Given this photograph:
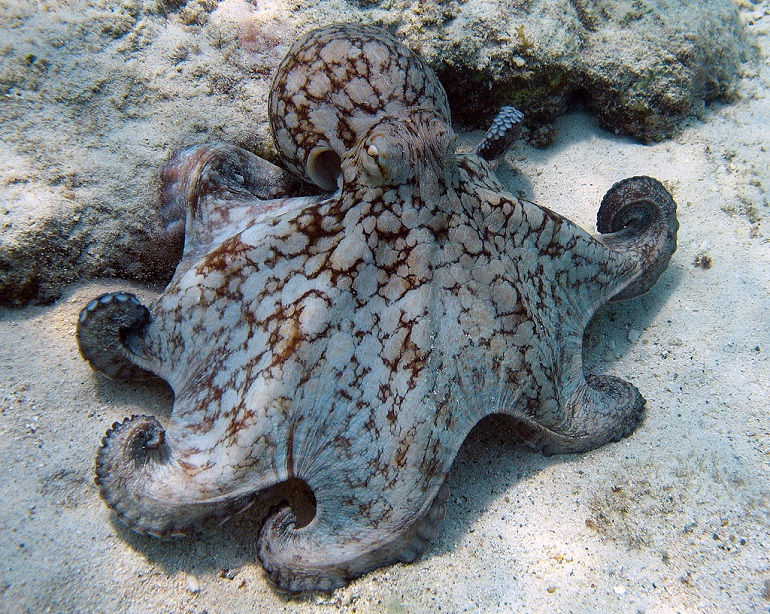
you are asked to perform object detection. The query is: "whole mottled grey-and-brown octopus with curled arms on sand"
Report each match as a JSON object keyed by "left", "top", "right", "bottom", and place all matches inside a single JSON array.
[{"left": 77, "top": 25, "right": 678, "bottom": 592}]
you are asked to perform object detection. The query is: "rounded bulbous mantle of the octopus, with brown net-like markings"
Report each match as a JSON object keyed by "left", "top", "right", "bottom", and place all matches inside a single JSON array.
[{"left": 269, "top": 24, "right": 450, "bottom": 182}]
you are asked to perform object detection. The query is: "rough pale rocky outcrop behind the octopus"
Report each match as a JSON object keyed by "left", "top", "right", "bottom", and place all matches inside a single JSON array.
[{"left": 0, "top": 0, "right": 748, "bottom": 305}]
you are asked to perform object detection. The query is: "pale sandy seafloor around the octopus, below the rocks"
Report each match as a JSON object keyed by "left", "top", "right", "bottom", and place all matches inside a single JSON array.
[{"left": 0, "top": 3, "right": 770, "bottom": 614}]
